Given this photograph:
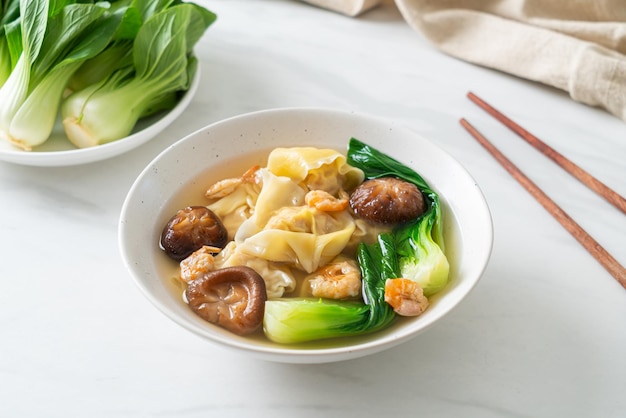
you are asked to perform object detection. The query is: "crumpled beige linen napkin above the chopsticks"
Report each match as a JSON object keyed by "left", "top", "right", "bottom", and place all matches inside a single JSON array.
[{"left": 300, "top": 0, "right": 626, "bottom": 121}]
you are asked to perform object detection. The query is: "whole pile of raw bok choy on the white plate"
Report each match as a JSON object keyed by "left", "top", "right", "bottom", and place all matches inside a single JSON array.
[{"left": 0, "top": 0, "right": 215, "bottom": 150}]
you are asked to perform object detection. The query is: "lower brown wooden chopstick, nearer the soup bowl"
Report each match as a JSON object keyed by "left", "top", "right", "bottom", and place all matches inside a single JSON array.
[{"left": 460, "top": 119, "right": 626, "bottom": 289}]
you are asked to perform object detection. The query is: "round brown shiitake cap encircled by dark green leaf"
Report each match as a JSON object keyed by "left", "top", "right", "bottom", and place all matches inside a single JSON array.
[{"left": 350, "top": 177, "right": 426, "bottom": 224}]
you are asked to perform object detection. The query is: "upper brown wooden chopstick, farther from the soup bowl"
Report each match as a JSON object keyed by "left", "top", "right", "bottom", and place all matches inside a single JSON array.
[{"left": 467, "top": 92, "right": 626, "bottom": 213}]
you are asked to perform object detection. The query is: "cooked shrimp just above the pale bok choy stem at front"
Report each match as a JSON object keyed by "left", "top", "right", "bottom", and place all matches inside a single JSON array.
[{"left": 309, "top": 260, "right": 361, "bottom": 299}]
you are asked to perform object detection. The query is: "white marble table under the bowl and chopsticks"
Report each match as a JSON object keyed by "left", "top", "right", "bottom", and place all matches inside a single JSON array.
[{"left": 0, "top": 0, "right": 626, "bottom": 418}]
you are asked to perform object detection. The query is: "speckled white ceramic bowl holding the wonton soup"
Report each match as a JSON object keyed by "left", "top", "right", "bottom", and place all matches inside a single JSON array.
[{"left": 119, "top": 109, "right": 493, "bottom": 363}]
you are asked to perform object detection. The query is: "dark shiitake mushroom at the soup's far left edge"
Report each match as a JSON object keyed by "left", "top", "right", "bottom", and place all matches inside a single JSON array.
[{"left": 160, "top": 206, "right": 228, "bottom": 261}]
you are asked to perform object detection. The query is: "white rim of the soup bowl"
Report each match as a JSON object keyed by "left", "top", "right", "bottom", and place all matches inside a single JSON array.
[{"left": 118, "top": 107, "right": 494, "bottom": 363}]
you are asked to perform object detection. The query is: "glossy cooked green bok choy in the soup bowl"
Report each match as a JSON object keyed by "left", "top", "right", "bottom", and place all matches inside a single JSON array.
[{"left": 263, "top": 138, "right": 449, "bottom": 343}]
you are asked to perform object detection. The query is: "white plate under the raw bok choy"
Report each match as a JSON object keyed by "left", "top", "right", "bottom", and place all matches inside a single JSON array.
[{"left": 0, "top": 66, "right": 200, "bottom": 167}]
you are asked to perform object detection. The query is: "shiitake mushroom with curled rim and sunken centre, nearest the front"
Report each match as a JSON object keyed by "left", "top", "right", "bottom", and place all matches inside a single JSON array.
[{"left": 185, "top": 266, "right": 267, "bottom": 335}]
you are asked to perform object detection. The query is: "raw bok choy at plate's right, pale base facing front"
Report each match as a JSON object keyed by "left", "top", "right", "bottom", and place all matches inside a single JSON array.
[{"left": 61, "top": 3, "right": 215, "bottom": 148}]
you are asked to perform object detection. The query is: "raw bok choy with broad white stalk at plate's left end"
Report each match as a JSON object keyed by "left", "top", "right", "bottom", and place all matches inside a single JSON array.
[{"left": 0, "top": 0, "right": 137, "bottom": 150}]
